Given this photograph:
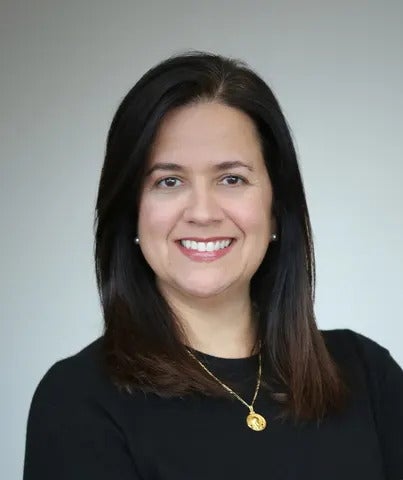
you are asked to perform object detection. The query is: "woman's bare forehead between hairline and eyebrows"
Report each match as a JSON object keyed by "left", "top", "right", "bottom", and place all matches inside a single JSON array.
[{"left": 150, "top": 102, "right": 261, "bottom": 162}]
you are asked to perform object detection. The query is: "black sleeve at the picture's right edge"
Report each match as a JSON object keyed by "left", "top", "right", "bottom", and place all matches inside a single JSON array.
[{"left": 355, "top": 333, "right": 403, "bottom": 480}]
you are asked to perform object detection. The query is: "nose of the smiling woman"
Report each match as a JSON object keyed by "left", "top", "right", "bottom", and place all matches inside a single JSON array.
[{"left": 183, "top": 182, "right": 224, "bottom": 225}]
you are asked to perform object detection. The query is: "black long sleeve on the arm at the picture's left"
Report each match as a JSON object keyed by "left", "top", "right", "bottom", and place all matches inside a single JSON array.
[{"left": 24, "top": 362, "right": 140, "bottom": 480}]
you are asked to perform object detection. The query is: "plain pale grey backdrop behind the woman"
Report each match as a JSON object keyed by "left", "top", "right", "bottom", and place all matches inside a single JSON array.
[{"left": 0, "top": 0, "right": 403, "bottom": 480}]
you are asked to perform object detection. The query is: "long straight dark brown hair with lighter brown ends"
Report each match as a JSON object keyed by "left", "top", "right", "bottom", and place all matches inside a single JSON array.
[{"left": 94, "top": 51, "right": 346, "bottom": 420}]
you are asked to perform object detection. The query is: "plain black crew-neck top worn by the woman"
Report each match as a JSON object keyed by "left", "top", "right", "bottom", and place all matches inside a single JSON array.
[{"left": 24, "top": 330, "right": 403, "bottom": 480}]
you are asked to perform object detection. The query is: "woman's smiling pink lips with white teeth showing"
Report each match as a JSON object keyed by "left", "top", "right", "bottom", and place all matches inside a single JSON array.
[{"left": 176, "top": 237, "right": 235, "bottom": 262}]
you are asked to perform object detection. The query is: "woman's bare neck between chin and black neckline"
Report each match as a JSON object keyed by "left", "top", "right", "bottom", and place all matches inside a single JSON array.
[{"left": 159, "top": 284, "right": 258, "bottom": 358}]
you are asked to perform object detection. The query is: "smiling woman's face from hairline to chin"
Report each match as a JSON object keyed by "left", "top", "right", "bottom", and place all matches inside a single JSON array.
[{"left": 138, "top": 103, "right": 274, "bottom": 298}]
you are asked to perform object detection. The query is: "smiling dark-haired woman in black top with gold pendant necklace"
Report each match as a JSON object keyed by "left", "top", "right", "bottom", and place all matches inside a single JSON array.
[{"left": 24, "top": 52, "right": 403, "bottom": 480}]
